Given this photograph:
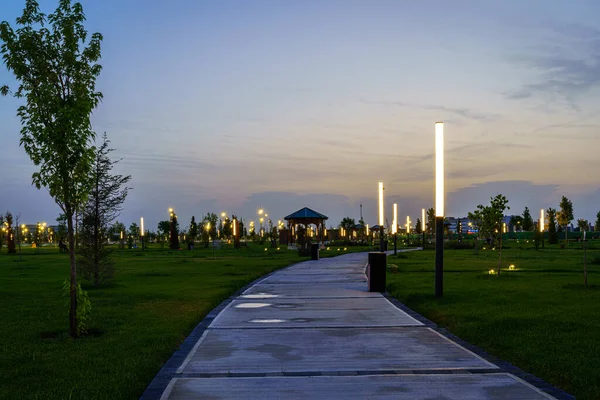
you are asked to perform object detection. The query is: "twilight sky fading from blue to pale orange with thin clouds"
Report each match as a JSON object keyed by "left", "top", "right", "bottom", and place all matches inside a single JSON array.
[{"left": 0, "top": 0, "right": 600, "bottom": 229}]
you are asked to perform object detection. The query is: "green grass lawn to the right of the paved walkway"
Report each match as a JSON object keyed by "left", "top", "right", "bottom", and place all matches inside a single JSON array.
[{"left": 387, "top": 241, "right": 600, "bottom": 399}]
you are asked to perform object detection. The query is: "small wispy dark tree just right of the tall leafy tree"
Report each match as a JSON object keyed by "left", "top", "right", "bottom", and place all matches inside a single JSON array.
[{"left": 78, "top": 133, "right": 131, "bottom": 286}]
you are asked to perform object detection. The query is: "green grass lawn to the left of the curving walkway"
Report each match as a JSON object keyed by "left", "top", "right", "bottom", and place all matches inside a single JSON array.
[{"left": 0, "top": 244, "right": 366, "bottom": 399}]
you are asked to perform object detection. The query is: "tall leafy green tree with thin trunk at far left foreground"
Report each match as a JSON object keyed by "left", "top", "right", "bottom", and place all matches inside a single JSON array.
[{"left": 0, "top": 0, "right": 102, "bottom": 337}]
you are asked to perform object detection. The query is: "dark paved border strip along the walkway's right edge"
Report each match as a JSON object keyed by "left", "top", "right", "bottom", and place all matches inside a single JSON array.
[{"left": 382, "top": 291, "right": 576, "bottom": 400}]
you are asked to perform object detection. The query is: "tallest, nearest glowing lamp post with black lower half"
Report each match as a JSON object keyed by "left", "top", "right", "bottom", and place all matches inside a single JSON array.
[{"left": 435, "top": 122, "right": 444, "bottom": 297}]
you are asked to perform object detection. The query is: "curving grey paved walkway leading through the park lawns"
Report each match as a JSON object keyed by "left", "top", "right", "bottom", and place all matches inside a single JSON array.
[{"left": 154, "top": 253, "right": 553, "bottom": 400}]
